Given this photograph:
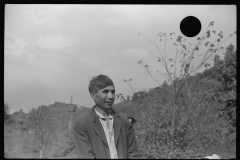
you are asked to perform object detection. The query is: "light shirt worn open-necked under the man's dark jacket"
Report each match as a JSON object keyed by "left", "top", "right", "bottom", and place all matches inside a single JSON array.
[{"left": 94, "top": 108, "right": 118, "bottom": 159}]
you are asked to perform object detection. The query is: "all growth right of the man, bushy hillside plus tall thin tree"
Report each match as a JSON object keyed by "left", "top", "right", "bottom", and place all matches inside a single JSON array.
[{"left": 117, "top": 21, "right": 236, "bottom": 158}]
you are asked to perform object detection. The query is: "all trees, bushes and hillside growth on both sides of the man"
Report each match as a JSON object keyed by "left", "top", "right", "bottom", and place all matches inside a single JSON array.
[{"left": 4, "top": 21, "right": 237, "bottom": 159}]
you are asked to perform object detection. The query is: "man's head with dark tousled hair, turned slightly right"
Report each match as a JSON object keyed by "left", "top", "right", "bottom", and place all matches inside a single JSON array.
[{"left": 88, "top": 75, "right": 115, "bottom": 109}]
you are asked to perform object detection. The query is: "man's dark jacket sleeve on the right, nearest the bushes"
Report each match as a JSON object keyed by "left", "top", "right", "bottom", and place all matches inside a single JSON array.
[{"left": 127, "top": 118, "right": 140, "bottom": 159}]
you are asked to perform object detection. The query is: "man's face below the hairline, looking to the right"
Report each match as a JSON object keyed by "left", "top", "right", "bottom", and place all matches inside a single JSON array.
[{"left": 91, "top": 85, "right": 115, "bottom": 109}]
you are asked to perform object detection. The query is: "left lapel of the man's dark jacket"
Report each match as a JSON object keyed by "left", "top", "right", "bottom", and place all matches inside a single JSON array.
[{"left": 92, "top": 107, "right": 108, "bottom": 147}]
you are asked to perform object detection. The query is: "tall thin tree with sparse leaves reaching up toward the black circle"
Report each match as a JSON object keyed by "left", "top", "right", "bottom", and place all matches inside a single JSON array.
[{"left": 138, "top": 21, "right": 236, "bottom": 158}]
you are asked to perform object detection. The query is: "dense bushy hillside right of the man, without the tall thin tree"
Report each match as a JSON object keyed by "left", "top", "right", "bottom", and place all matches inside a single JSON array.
[{"left": 114, "top": 45, "right": 236, "bottom": 158}]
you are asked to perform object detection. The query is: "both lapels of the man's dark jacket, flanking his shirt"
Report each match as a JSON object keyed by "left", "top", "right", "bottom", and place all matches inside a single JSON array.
[{"left": 92, "top": 106, "right": 121, "bottom": 147}]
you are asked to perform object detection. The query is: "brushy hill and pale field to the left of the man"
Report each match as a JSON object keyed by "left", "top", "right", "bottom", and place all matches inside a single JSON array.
[{"left": 4, "top": 102, "right": 89, "bottom": 158}]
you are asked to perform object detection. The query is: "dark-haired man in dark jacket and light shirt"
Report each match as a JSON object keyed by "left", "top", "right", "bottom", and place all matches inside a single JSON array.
[{"left": 74, "top": 75, "right": 138, "bottom": 159}]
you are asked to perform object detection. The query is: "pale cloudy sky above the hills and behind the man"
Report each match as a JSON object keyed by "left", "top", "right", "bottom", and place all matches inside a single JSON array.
[{"left": 4, "top": 4, "right": 236, "bottom": 112}]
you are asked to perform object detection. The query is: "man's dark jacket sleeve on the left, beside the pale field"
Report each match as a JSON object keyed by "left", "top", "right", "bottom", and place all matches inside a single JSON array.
[{"left": 73, "top": 123, "right": 96, "bottom": 158}]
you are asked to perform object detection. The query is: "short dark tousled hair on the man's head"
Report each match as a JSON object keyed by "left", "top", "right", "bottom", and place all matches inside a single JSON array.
[{"left": 88, "top": 74, "right": 114, "bottom": 93}]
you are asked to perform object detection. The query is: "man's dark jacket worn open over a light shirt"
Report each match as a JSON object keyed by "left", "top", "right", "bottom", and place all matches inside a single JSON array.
[{"left": 73, "top": 107, "right": 139, "bottom": 159}]
